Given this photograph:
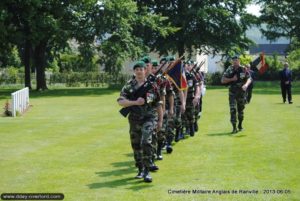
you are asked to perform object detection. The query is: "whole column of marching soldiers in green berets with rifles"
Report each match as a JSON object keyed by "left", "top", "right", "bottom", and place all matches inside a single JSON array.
[{"left": 117, "top": 56, "right": 205, "bottom": 182}]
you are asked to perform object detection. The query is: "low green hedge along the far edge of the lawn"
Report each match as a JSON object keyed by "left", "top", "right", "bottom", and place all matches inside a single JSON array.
[{"left": 0, "top": 68, "right": 300, "bottom": 87}]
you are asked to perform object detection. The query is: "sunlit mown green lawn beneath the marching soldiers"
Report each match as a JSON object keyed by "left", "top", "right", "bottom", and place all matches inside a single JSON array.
[{"left": 0, "top": 83, "right": 300, "bottom": 201}]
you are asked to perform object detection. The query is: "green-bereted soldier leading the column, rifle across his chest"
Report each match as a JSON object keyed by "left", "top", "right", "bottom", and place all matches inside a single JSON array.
[{"left": 117, "top": 61, "right": 162, "bottom": 182}]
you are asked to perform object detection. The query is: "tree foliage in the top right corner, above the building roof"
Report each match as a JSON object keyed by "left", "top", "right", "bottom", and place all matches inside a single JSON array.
[{"left": 258, "top": 0, "right": 300, "bottom": 44}]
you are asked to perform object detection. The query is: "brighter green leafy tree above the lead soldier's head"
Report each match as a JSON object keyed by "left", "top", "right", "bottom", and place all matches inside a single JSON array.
[{"left": 94, "top": 0, "right": 176, "bottom": 74}]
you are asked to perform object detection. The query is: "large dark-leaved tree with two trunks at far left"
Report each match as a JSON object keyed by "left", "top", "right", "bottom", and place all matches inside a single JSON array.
[{"left": 0, "top": 0, "right": 97, "bottom": 90}]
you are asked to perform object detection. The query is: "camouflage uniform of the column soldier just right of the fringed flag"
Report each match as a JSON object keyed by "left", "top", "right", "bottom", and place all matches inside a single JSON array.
[{"left": 182, "top": 72, "right": 199, "bottom": 136}]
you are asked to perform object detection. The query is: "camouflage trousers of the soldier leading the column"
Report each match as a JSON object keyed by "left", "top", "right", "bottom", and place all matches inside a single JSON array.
[{"left": 129, "top": 118, "right": 156, "bottom": 168}]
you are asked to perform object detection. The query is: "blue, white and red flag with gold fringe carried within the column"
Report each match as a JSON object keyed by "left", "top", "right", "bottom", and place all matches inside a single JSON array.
[{"left": 165, "top": 59, "right": 187, "bottom": 90}]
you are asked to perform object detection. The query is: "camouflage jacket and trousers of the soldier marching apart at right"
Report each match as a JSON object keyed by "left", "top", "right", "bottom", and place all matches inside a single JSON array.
[{"left": 223, "top": 66, "right": 251, "bottom": 128}]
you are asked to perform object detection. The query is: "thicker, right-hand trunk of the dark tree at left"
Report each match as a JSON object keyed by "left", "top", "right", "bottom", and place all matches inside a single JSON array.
[{"left": 34, "top": 41, "right": 48, "bottom": 91}]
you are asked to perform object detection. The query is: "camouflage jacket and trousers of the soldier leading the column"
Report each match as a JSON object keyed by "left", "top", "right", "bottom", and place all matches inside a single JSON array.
[{"left": 120, "top": 79, "right": 160, "bottom": 169}]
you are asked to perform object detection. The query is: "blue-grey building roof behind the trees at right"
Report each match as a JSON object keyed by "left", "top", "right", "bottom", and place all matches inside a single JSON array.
[{"left": 249, "top": 44, "right": 289, "bottom": 55}]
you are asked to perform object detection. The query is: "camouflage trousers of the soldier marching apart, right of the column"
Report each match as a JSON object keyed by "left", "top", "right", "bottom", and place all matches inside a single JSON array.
[{"left": 229, "top": 90, "right": 246, "bottom": 124}]
